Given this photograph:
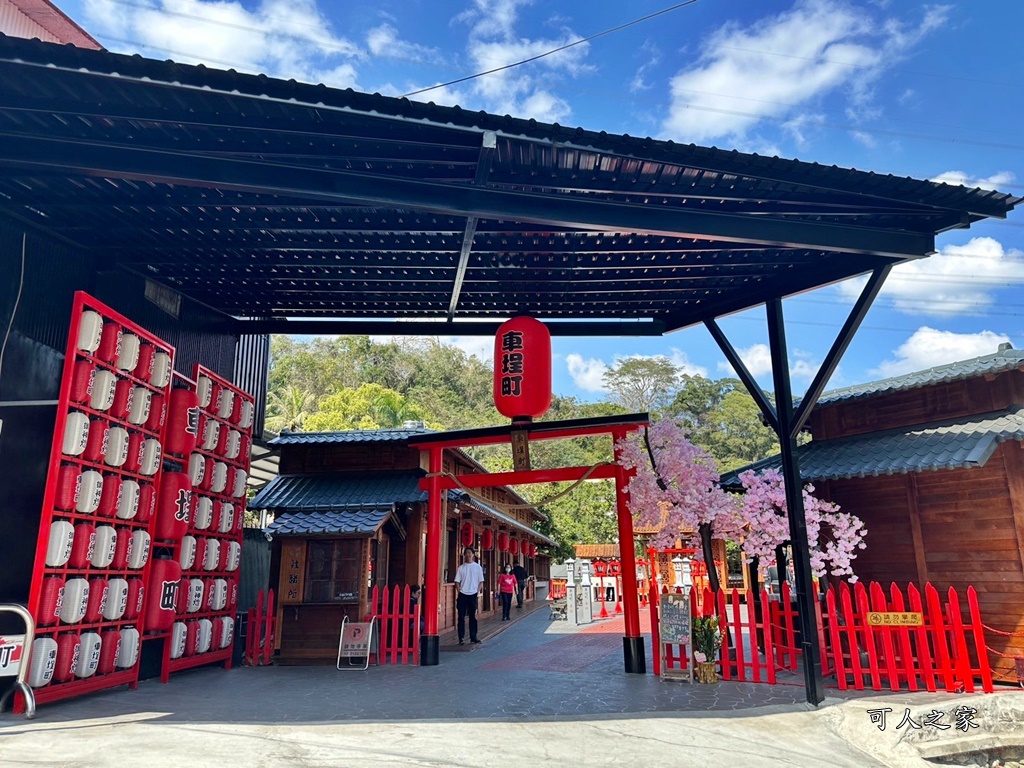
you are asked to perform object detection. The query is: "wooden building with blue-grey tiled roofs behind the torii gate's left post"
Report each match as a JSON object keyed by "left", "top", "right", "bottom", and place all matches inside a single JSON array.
[{"left": 250, "top": 425, "right": 554, "bottom": 664}]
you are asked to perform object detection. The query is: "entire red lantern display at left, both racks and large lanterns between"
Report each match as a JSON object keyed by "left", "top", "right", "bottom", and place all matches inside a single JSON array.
[{"left": 20, "top": 292, "right": 255, "bottom": 703}]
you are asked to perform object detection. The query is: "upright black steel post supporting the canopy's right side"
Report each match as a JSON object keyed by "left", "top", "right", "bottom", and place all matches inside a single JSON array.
[{"left": 766, "top": 299, "right": 825, "bottom": 706}]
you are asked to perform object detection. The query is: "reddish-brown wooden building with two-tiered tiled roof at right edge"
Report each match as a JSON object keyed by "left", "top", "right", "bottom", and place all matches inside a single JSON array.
[{"left": 722, "top": 344, "right": 1024, "bottom": 682}]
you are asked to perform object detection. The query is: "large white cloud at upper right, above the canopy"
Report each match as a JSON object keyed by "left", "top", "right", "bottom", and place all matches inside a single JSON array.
[{"left": 663, "top": 0, "right": 948, "bottom": 143}]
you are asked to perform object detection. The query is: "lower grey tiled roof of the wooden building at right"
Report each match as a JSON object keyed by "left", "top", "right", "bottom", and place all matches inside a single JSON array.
[{"left": 721, "top": 406, "right": 1024, "bottom": 488}]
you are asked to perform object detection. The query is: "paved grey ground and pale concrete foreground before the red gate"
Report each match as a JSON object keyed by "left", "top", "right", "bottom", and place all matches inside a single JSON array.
[{"left": 0, "top": 606, "right": 1024, "bottom": 768}]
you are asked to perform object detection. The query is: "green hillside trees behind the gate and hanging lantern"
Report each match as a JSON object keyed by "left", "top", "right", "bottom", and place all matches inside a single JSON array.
[{"left": 267, "top": 336, "right": 777, "bottom": 556}]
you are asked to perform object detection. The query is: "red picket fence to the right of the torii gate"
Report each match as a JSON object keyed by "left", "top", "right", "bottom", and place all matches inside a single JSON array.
[{"left": 651, "top": 583, "right": 992, "bottom": 692}]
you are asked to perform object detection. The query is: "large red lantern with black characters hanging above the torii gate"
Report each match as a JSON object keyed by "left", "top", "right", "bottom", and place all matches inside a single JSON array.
[{"left": 495, "top": 315, "right": 551, "bottom": 420}]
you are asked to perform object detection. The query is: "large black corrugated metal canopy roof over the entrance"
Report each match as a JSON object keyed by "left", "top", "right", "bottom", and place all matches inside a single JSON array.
[{"left": 0, "top": 36, "right": 1020, "bottom": 335}]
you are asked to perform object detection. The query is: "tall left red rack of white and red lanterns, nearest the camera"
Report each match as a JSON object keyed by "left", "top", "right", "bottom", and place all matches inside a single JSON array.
[{"left": 29, "top": 292, "right": 174, "bottom": 703}]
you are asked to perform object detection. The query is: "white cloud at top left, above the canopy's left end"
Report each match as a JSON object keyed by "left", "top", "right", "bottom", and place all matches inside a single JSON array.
[{"left": 83, "top": 0, "right": 366, "bottom": 88}]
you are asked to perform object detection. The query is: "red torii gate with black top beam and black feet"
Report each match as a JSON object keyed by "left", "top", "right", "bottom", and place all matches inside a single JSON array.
[{"left": 409, "top": 414, "right": 650, "bottom": 674}]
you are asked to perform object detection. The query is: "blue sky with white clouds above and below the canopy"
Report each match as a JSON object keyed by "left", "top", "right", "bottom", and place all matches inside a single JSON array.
[{"left": 57, "top": 0, "right": 1024, "bottom": 399}]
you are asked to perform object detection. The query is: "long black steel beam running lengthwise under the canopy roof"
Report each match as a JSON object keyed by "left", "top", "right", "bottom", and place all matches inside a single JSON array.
[{"left": 0, "top": 133, "right": 935, "bottom": 260}]
